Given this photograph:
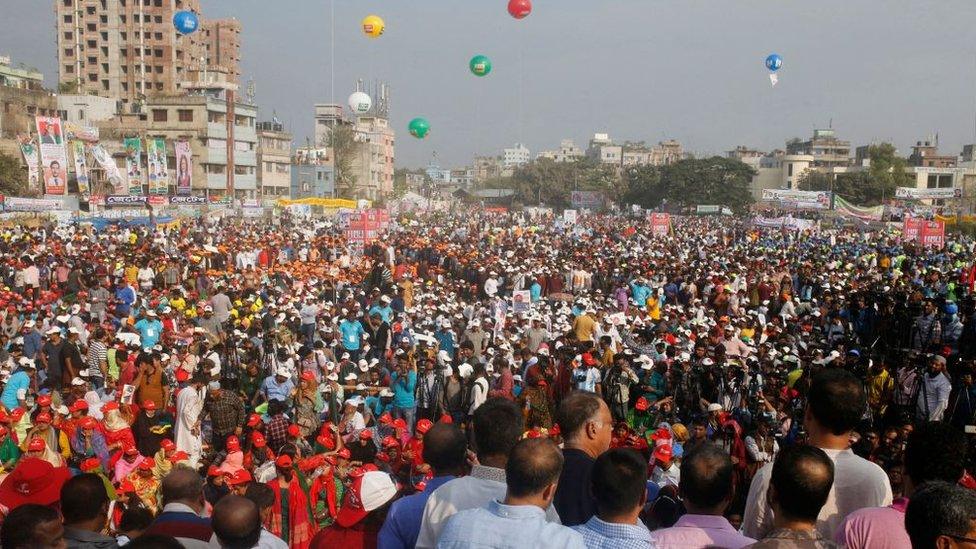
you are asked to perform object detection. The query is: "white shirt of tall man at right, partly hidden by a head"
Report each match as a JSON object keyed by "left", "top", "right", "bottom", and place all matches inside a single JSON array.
[{"left": 742, "top": 448, "right": 892, "bottom": 539}]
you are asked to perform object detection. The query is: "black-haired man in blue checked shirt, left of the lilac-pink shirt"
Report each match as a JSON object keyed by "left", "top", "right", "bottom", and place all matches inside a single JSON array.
[{"left": 573, "top": 448, "right": 654, "bottom": 549}]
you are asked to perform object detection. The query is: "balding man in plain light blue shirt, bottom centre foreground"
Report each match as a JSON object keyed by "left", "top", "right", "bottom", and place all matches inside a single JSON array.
[{"left": 437, "top": 438, "right": 586, "bottom": 549}]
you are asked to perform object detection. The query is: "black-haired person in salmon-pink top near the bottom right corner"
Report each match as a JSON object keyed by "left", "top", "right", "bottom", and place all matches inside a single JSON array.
[{"left": 834, "top": 423, "right": 966, "bottom": 549}]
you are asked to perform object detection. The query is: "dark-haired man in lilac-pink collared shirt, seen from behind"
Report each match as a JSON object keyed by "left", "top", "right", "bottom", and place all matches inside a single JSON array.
[{"left": 651, "top": 443, "right": 756, "bottom": 549}]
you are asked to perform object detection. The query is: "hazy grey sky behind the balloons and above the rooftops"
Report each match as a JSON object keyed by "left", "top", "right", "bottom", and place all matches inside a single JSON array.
[{"left": 0, "top": 0, "right": 976, "bottom": 167}]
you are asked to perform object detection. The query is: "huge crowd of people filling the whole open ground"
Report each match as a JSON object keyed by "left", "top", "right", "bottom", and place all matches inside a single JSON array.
[{"left": 0, "top": 207, "right": 976, "bottom": 549}]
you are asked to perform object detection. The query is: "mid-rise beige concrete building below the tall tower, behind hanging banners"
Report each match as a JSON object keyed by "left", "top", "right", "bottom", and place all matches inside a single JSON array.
[{"left": 93, "top": 72, "right": 258, "bottom": 199}]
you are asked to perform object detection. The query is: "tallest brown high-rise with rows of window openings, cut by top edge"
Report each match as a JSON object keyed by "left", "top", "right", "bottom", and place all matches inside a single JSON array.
[{"left": 55, "top": 0, "right": 206, "bottom": 104}]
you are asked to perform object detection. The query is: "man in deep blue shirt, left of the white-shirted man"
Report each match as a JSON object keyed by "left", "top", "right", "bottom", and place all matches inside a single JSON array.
[{"left": 378, "top": 423, "right": 467, "bottom": 549}]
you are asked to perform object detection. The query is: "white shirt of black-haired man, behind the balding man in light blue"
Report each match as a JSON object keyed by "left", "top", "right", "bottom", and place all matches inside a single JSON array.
[{"left": 416, "top": 465, "right": 560, "bottom": 549}]
